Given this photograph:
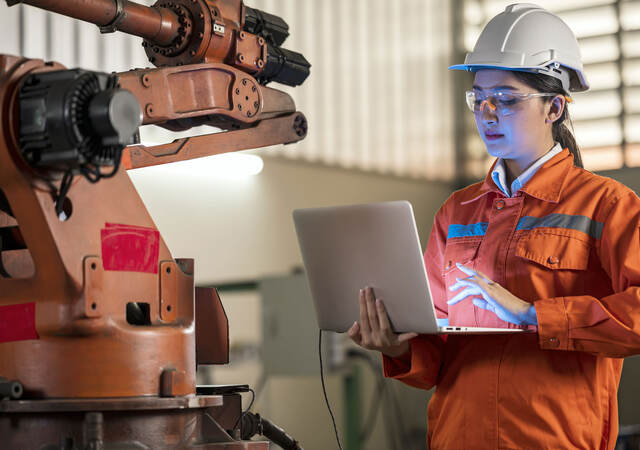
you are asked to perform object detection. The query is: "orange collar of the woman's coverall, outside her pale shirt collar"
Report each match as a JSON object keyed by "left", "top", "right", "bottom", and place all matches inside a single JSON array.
[{"left": 461, "top": 148, "right": 573, "bottom": 205}]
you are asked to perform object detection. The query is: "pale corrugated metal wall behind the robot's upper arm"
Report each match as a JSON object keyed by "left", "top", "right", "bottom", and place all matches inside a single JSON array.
[{"left": 0, "top": 0, "right": 454, "bottom": 180}]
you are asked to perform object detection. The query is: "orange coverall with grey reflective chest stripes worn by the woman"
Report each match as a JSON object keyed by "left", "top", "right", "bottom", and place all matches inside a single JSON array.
[{"left": 383, "top": 149, "right": 640, "bottom": 450}]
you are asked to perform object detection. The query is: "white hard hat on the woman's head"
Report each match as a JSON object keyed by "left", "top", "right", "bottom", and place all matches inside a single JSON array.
[{"left": 449, "top": 3, "right": 589, "bottom": 92}]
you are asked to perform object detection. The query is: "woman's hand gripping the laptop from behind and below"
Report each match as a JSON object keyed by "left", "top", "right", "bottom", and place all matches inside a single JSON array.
[{"left": 347, "top": 287, "right": 418, "bottom": 358}]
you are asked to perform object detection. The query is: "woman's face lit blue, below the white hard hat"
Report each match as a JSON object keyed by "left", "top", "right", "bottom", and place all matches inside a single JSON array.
[{"left": 473, "top": 69, "right": 553, "bottom": 167}]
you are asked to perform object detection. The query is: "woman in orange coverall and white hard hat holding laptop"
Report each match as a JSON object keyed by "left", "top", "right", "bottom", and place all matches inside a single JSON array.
[{"left": 349, "top": 4, "right": 640, "bottom": 449}]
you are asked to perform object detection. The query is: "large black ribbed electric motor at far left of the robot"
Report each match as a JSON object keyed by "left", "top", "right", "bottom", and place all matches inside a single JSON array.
[{"left": 18, "top": 69, "right": 142, "bottom": 216}]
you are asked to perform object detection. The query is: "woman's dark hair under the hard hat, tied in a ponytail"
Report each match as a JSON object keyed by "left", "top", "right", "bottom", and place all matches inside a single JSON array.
[{"left": 513, "top": 71, "right": 584, "bottom": 167}]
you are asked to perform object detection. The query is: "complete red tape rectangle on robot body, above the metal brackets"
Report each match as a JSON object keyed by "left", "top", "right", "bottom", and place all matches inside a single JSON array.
[{"left": 100, "top": 223, "right": 160, "bottom": 273}]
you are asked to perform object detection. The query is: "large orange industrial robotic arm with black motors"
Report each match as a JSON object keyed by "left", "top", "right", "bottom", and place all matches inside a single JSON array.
[{"left": 0, "top": 0, "right": 310, "bottom": 449}]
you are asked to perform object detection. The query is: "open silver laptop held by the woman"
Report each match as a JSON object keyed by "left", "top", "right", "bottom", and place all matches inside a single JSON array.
[{"left": 293, "top": 201, "right": 528, "bottom": 334}]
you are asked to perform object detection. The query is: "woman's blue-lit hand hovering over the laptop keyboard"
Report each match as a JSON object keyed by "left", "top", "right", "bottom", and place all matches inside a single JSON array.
[{"left": 447, "top": 263, "right": 538, "bottom": 325}]
